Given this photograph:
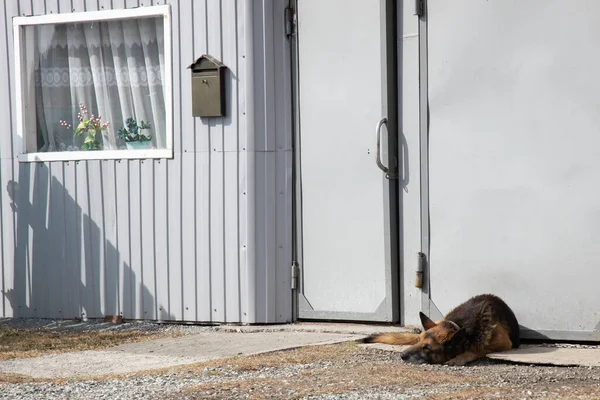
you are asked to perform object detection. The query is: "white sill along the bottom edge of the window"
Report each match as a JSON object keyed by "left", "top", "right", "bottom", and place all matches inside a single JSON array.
[{"left": 18, "top": 149, "right": 173, "bottom": 162}]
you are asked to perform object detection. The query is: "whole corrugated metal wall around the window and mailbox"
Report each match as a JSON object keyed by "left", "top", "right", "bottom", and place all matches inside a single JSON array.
[{"left": 0, "top": 0, "right": 292, "bottom": 323}]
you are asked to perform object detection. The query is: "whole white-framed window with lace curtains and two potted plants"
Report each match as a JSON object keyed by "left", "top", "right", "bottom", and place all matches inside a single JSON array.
[{"left": 14, "top": 5, "right": 173, "bottom": 161}]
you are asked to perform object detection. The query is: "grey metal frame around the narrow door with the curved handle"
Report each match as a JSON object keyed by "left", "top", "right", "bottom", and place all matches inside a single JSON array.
[{"left": 288, "top": 0, "right": 402, "bottom": 323}]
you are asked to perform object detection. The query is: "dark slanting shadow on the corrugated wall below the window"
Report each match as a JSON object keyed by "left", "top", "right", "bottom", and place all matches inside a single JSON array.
[{"left": 4, "top": 163, "right": 173, "bottom": 320}]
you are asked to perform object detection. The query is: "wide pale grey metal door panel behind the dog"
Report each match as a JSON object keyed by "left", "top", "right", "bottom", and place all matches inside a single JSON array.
[{"left": 427, "top": 0, "right": 600, "bottom": 340}]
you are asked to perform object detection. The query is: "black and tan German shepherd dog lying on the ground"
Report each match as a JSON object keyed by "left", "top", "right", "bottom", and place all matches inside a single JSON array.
[{"left": 364, "top": 294, "right": 520, "bottom": 365}]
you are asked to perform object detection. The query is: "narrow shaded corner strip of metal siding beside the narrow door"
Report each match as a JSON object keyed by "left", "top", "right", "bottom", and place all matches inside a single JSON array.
[{"left": 254, "top": 0, "right": 293, "bottom": 321}]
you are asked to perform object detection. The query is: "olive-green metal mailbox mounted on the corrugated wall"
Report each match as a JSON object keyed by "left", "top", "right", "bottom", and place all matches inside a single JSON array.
[{"left": 188, "top": 54, "right": 226, "bottom": 117}]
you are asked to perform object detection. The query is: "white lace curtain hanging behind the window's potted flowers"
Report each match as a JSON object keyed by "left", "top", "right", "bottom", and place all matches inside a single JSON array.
[{"left": 31, "top": 18, "right": 166, "bottom": 152}]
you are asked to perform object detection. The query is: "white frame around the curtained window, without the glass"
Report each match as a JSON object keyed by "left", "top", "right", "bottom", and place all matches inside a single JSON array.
[{"left": 13, "top": 4, "right": 173, "bottom": 162}]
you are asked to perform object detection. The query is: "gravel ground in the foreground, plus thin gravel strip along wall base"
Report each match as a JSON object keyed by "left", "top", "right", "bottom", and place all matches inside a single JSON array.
[{"left": 0, "top": 320, "right": 600, "bottom": 400}]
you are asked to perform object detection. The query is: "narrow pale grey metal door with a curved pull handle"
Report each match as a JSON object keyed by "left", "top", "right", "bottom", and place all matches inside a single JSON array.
[{"left": 297, "top": 0, "right": 397, "bottom": 321}]
